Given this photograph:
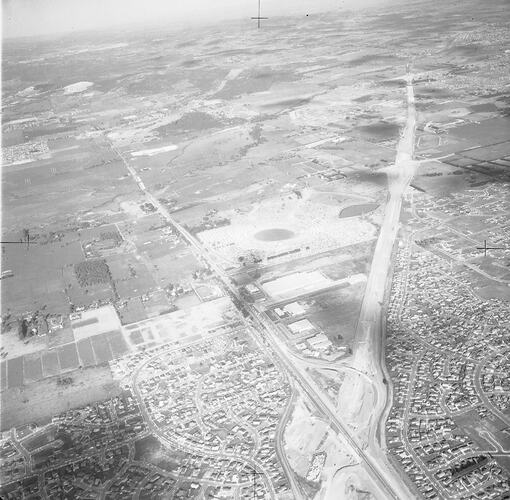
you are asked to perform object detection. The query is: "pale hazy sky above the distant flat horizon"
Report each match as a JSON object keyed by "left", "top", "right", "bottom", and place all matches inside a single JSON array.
[{"left": 2, "top": 0, "right": 388, "bottom": 37}]
